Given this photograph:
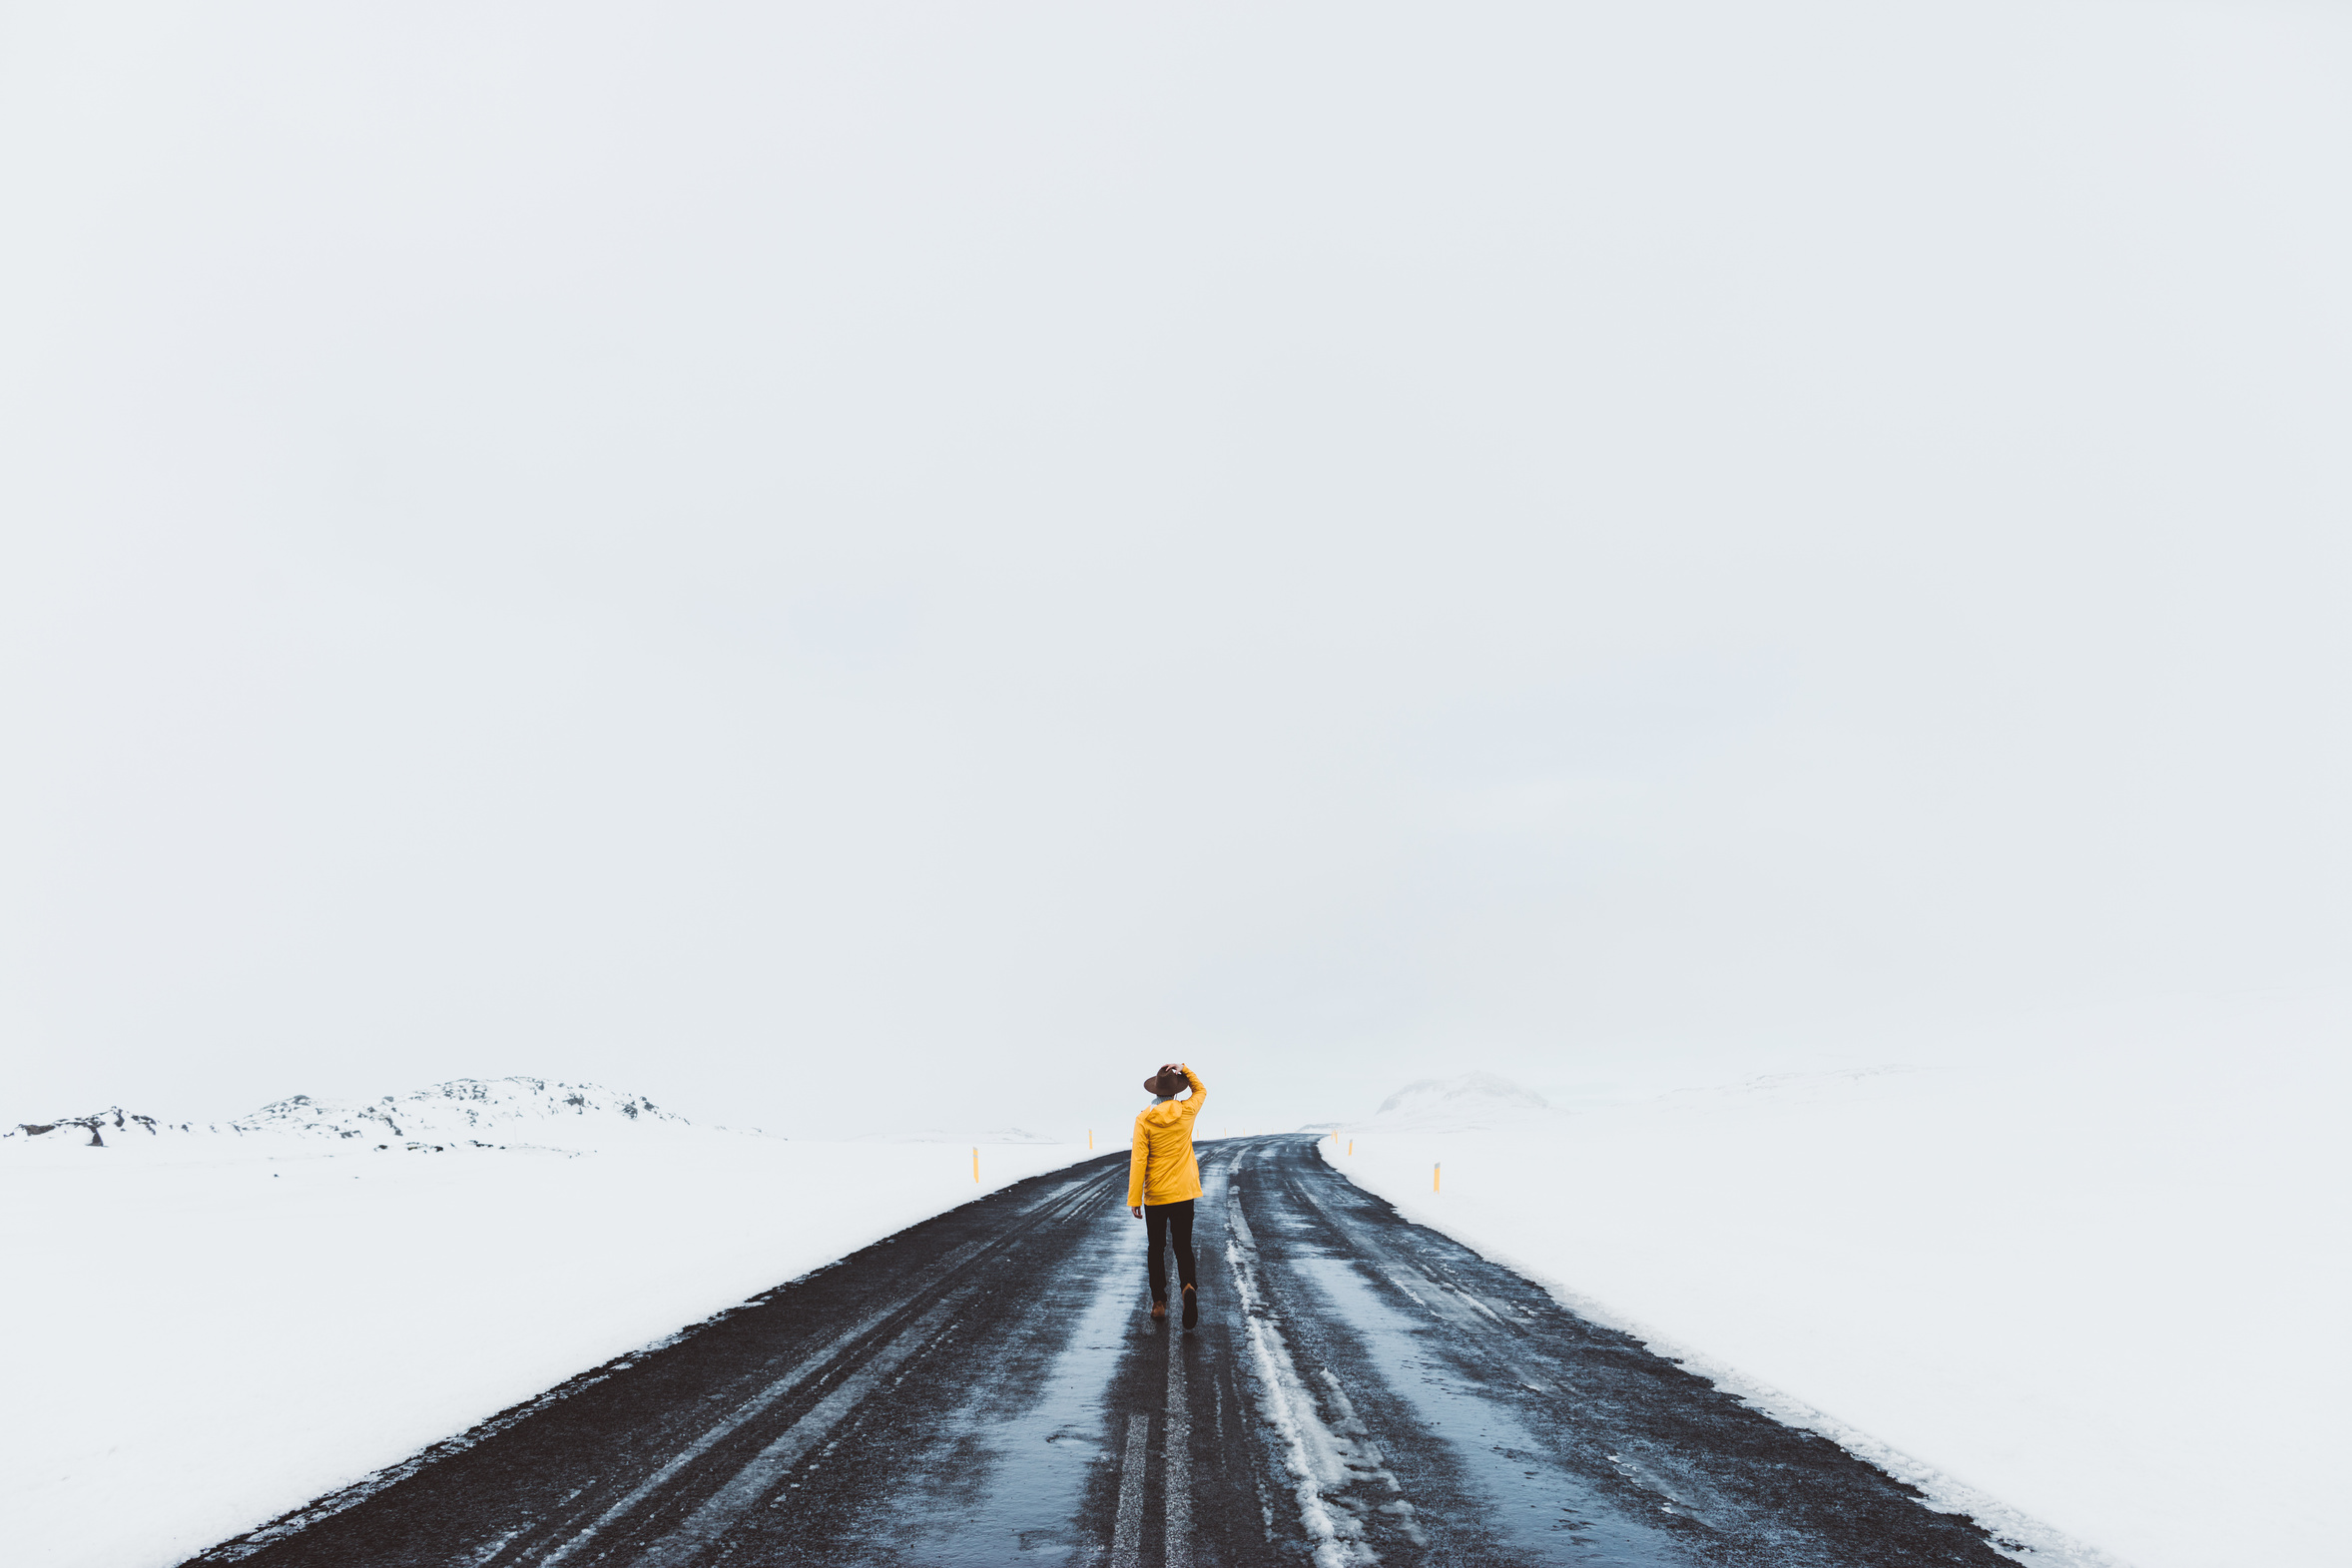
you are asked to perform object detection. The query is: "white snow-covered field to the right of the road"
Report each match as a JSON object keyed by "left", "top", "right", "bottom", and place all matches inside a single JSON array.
[{"left": 1322, "top": 1004, "right": 2352, "bottom": 1568}]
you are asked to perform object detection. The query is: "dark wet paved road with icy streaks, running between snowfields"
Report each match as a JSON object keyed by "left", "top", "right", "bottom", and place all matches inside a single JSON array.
[{"left": 196, "top": 1138, "right": 2009, "bottom": 1568}]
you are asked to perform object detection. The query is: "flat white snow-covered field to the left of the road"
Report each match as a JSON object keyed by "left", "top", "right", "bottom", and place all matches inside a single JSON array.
[{"left": 0, "top": 1086, "right": 1086, "bottom": 1568}]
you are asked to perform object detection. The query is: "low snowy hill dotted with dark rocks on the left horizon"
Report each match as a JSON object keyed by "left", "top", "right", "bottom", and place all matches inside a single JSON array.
[{"left": 0, "top": 1077, "right": 729, "bottom": 1150}]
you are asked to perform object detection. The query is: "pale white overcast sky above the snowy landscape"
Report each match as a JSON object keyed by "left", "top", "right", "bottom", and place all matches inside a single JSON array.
[{"left": 0, "top": 0, "right": 2352, "bottom": 1133}]
